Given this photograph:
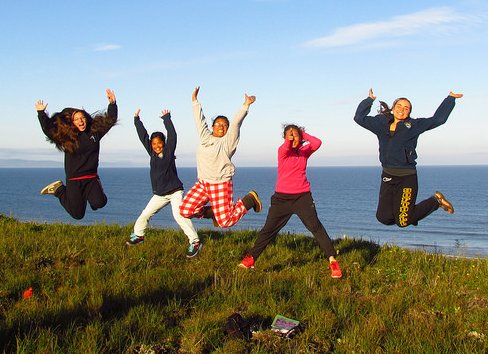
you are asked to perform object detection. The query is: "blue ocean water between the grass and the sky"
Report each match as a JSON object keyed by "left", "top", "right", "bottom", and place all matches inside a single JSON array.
[{"left": 0, "top": 166, "right": 488, "bottom": 257}]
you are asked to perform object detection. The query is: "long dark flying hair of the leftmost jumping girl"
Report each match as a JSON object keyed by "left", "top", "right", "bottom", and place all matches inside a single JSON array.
[{"left": 48, "top": 107, "right": 115, "bottom": 154}]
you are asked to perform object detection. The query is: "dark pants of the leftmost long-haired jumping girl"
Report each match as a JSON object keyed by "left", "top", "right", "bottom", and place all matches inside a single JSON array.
[{"left": 55, "top": 177, "right": 108, "bottom": 220}]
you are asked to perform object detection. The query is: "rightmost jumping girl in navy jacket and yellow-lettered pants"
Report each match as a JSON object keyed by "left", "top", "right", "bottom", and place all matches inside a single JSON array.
[{"left": 354, "top": 89, "right": 463, "bottom": 227}]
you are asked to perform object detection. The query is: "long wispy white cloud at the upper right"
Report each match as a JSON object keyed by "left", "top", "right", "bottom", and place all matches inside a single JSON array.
[{"left": 304, "top": 7, "right": 473, "bottom": 48}]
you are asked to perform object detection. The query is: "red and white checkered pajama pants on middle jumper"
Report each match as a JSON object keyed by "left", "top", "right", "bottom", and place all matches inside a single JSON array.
[{"left": 180, "top": 179, "right": 247, "bottom": 227}]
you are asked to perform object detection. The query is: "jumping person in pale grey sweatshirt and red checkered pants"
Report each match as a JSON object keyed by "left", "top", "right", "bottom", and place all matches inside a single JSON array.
[{"left": 180, "top": 87, "right": 262, "bottom": 227}]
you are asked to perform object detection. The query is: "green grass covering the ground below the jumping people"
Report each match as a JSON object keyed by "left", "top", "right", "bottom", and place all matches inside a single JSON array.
[{"left": 0, "top": 215, "right": 488, "bottom": 353}]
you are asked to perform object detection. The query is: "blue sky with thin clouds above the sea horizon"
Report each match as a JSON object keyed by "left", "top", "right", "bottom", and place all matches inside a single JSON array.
[{"left": 0, "top": 0, "right": 488, "bottom": 167}]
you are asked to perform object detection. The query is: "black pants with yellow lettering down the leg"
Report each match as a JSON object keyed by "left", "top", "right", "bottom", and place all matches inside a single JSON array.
[{"left": 376, "top": 172, "right": 439, "bottom": 227}]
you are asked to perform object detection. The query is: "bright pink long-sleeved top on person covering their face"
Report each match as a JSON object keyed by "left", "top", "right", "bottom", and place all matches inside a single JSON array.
[{"left": 276, "top": 132, "right": 322, "bottom": 194}]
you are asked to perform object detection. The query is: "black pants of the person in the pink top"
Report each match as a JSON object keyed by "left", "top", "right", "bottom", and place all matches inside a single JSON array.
[{"left": 249, "top": 192, "right": 336, "bottom": 260}]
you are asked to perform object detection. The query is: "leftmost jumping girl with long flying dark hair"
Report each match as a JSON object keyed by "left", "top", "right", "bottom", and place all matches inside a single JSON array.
[{"left": 35, "top": 89, "right": 117, "bottom": 219}]
